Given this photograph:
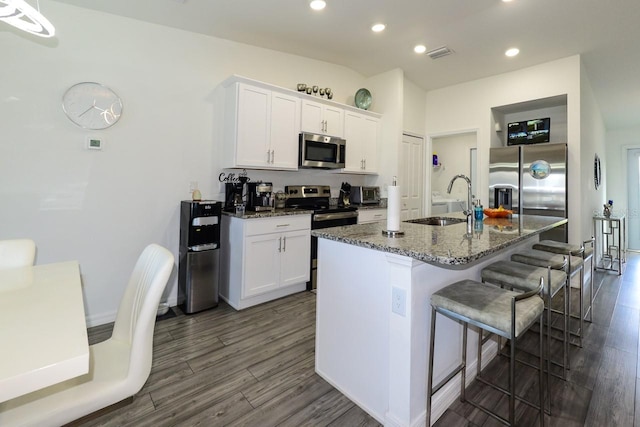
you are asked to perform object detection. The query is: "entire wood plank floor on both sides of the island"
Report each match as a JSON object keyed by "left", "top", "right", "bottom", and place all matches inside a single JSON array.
[{"left": 82, "top": 255, "right": 640, "bottom": 427}]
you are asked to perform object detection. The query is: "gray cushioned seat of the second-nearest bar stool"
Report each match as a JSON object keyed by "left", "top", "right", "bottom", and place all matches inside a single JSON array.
[{"left": 481, "top": 260, "right": 567, "bottom": 296}]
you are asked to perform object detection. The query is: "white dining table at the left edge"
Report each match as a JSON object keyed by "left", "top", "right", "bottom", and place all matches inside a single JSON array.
[{"left": 0, "top": 261, "right": 89, "bottom": 402}]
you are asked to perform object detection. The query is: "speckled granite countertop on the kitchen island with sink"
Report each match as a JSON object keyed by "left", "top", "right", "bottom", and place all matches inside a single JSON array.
[{"left": 311, "top": 213, "right": 567, "bottom": 268}]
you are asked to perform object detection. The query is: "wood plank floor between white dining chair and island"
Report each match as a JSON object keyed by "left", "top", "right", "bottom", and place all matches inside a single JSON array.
[{"left": 82, "top": 292, "right": 380, "bottom": 427}]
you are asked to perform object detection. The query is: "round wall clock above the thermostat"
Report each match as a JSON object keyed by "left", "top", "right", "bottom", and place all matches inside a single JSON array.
[{"left": 62, "top": 82, "right": 122, "bottom": 130}]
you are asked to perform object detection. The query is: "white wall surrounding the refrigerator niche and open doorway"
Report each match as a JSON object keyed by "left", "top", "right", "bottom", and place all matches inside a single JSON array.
[{"left": 426, "top": 56, "right": 592, "bottom": 241}]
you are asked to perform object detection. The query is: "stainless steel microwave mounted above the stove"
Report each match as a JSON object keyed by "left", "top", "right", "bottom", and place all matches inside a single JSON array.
[{"left": 298, "top": 132, "right": 347, "bottom": 169}]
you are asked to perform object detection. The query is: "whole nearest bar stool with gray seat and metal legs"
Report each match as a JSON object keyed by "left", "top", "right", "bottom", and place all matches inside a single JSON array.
[{"left": 427, "top": 277, "right": 544, "bottom": 427}]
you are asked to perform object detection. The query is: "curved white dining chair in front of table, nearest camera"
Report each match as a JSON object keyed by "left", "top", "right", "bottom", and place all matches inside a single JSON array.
[{"left": 0, "top": 244, "right": 174, "bottom": 427}]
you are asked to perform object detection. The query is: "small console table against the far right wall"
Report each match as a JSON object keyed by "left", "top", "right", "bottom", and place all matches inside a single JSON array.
[{"left": 593, "top": 214, "right": 627, "bottom": 275}]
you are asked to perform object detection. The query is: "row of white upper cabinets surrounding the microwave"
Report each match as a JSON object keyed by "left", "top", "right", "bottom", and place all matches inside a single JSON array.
[{"left": 220, "top": 76, "right": 380, "bottom": 174}]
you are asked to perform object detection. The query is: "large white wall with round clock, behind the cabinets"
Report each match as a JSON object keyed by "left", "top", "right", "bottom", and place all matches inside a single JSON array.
[{"left": 0, "top": 0, "right": 384, "bottom": 325}]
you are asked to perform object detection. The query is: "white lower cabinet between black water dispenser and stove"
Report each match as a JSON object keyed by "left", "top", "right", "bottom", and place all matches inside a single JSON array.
[{"left": 220, "top": 215, "right": 311, "bottom": 310}]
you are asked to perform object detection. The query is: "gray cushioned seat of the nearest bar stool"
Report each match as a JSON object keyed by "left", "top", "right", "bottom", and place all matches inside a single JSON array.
[{"left": 431, "top": 277, "right": 544, "bottom": 337}]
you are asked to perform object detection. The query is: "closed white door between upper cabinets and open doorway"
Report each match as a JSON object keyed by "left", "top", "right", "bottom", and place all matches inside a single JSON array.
[{"left": 399, "top": 134, "right": 425, "bottom": 221}]
